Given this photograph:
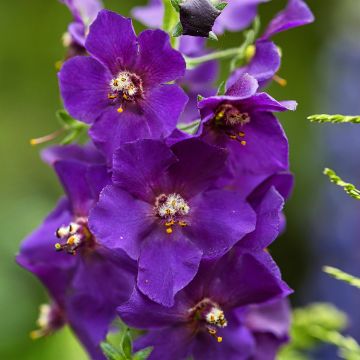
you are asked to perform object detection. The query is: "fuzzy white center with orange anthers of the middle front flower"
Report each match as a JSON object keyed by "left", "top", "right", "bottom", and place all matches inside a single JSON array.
[{"left": 154, "top": 193, "right": 190, "bottom": 234}]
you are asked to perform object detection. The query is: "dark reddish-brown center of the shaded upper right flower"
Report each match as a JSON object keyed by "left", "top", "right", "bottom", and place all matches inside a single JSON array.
[{"left": 213, "top": 104, "right": 251, "bottom": 146}]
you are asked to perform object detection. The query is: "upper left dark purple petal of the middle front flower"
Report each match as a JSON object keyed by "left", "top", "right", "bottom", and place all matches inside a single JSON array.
[{"left": 113, "top": 139, "right": 178, "bottom": 201}]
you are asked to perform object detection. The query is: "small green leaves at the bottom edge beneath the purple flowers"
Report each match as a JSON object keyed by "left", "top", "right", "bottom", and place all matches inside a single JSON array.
[{"left": 101, "top": 326, "right": 152, "bottom": 360}]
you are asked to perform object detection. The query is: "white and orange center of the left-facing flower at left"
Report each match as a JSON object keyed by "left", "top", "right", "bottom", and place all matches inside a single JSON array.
[{"left": 55, "top": 218, "right": 95, "bottom": 255}]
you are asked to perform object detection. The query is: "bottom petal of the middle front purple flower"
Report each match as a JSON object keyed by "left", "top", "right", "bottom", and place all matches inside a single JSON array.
[{"left": 138, "top": 229, "right": 202, "bottom": 307}]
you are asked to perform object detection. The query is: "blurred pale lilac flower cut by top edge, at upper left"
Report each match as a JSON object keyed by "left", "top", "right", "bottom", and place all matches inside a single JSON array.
[{"left": 60, "top": 0, "right": 103, "bottom": 50}]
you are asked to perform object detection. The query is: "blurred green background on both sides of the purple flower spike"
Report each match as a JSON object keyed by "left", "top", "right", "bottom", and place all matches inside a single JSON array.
[{"left": 0, "top": 0, "right": 359, "bottom": 360}]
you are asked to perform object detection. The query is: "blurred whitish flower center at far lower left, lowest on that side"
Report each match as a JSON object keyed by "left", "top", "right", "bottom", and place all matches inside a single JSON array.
[{"left": 30, "top": 303, "right": 65, "bottom": 339}]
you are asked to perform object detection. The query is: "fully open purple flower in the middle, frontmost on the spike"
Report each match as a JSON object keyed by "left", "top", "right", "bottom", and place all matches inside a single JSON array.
[{"left": 90, "top": 139, "right": 256, "bottom": 306}]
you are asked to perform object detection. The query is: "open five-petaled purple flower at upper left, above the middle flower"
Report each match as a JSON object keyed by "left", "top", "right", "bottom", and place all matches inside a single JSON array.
[{"left": 59, "top": 10, "right": 187, "bottom": 161}]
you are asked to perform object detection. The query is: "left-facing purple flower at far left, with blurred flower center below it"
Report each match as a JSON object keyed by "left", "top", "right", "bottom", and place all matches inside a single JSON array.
[{"left": 17, "top": 145, "right": 136, "bottom": 359}]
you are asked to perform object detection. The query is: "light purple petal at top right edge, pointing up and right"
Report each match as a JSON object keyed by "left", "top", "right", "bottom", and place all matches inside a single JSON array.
[{"left": 262, "top": 0, "right": 314, "bottom": 39}]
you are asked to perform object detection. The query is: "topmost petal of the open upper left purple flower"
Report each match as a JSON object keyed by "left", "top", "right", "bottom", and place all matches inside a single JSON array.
[{"left": 85, "top": 10, "right": 138, "bottom": 76}]
